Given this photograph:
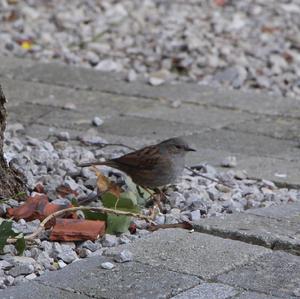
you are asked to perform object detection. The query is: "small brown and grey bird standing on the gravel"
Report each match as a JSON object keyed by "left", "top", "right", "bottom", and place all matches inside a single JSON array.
[{"left": 79, "top": 138, "right": 195, "bottom": 189}]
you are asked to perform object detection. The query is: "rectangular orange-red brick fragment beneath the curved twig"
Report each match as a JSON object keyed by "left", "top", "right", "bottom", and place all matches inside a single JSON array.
[{"left": 50, "top": 218, "right": 105, "bottom": 241}]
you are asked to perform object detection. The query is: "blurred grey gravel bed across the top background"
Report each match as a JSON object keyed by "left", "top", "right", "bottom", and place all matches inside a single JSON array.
[{"left": 0, "top": 0, "right": 300, "bottom": 98}]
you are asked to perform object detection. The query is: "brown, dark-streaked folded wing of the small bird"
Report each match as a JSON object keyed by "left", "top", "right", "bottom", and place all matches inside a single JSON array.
[{"left": 113, "top": 146, "right": 160, "bottom": 170}]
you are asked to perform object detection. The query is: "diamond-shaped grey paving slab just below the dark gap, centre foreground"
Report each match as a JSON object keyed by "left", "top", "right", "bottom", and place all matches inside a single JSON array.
[{"left": 106, "top": 229, "right": 270, "bottom": 279}]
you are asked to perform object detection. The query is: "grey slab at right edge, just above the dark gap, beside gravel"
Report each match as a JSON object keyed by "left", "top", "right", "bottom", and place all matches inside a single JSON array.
[{"left": 194, "top": 213, "right": 300, "bottom": 255}]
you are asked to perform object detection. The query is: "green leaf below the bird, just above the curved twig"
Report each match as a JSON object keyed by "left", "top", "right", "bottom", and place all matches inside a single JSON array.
[{"left": 102, "top": 191, "right": 139, "bottom": 213}]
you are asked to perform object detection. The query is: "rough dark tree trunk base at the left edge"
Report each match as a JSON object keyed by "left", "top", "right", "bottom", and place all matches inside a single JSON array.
[{"left": 0, "top": 84, "right": 26, "bottom": 198}]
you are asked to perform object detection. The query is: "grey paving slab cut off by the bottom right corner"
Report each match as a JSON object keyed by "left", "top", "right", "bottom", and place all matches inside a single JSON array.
[{"left": 217, "top": 251, "right": 300, "bottom": 298}]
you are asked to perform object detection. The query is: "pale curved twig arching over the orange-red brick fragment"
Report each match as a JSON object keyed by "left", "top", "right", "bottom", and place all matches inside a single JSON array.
[{"left": 7, "top": 206, "right": 152, "bottom": 243}]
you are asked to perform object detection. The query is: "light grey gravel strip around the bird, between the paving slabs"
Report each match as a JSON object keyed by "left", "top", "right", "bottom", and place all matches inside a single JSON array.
[{"left": 0, "top": 124, "right": 300, "bottom": 289}]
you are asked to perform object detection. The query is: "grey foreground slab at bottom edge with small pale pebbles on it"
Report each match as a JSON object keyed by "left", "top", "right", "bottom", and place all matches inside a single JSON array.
[{"left": 37, "top": 257, "right": 201, "bottom": 299}]
